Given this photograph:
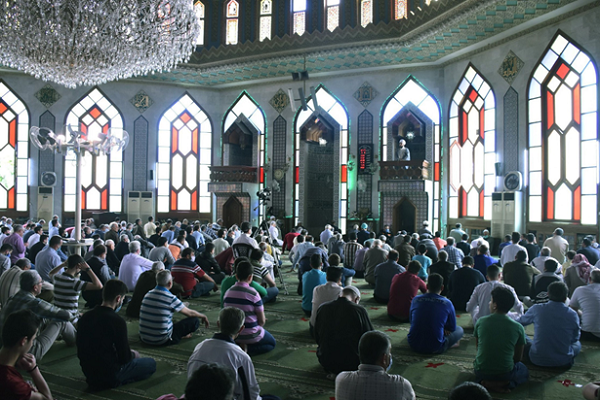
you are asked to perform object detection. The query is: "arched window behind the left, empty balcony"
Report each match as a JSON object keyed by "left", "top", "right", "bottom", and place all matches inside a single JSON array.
[{"left": 223, "top": 91, "right": 267, "bottom": 221}]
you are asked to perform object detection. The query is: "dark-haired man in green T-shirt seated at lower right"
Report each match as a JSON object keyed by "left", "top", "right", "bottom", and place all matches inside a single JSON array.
[{"left": 473, "top": 286, "right": 529, "bottom": 393}]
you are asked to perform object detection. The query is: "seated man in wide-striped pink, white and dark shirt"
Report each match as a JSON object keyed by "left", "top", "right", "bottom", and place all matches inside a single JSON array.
[{"left": 223, "top": 261, "right": 276, "bottom": 356}]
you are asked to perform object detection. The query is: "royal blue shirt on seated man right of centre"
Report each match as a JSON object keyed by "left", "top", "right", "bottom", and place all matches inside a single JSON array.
[{"left": 408, "top": 293, "right": 456, "bottom": 354}]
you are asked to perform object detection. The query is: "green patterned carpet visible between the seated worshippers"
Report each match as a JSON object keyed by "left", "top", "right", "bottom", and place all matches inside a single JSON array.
[{"left": 41, "top": 258, "right": 600, "bottom": 400}]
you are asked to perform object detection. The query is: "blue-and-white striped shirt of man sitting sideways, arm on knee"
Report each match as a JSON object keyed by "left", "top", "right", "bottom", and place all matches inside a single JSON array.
[{"left": 140, "top": 286, "right": 185, "bottom": 345}]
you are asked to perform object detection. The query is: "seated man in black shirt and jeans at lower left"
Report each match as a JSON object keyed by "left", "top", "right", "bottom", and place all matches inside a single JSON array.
[{"left": 77, "top": 279, "right": 156, "bottom": 390}]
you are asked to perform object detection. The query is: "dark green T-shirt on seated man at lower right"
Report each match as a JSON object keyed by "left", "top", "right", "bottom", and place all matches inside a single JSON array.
[{"left": 473, "top": 313, "right": 525, "bottom": 375}]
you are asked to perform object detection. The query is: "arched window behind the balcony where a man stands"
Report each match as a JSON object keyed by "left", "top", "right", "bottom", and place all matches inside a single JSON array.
[{"left": 380, "top": 76, "right": 441, "bottom": 230}]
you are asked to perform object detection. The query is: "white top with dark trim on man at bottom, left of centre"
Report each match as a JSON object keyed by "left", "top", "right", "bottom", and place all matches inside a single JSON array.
[{"left": 188, "top": 338, "right": 262, "bottom": 400}]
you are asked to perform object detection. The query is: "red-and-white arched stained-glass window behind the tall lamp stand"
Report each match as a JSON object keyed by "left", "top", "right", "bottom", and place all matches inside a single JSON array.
[{"left": 64, "top": 88, "right": 123, "bottom": 213}]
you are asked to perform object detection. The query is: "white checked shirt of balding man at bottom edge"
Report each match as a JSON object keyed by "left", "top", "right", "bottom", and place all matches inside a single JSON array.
[{"left": 335, "top": 364, "right": 416, "bottom": 400}]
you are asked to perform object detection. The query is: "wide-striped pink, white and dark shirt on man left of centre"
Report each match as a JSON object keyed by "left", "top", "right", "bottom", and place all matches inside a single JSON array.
[{"left": 223, "top": 282, "right": 265, "bottom": 344}]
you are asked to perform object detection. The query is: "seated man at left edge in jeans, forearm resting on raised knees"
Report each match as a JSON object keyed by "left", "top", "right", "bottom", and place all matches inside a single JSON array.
[{"left": 0, "top": 270, "right": 75, "bottom": 361}]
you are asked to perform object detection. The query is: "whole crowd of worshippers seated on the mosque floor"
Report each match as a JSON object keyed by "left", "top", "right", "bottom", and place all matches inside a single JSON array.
[{"left": 0, "top": 217, "right": 600, "bottom": 400}]
